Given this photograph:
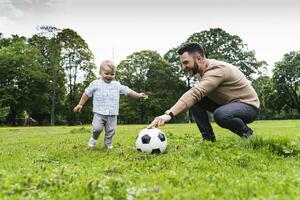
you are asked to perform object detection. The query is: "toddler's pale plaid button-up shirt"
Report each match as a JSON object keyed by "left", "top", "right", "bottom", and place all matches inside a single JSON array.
[{"left": 84, "top": 80, "right": 131, "bottom": 115}]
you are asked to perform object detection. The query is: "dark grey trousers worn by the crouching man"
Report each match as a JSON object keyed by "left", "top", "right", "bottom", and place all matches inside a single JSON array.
[{"left": 191, "top": 97, "right": 258, "bottom": 140}]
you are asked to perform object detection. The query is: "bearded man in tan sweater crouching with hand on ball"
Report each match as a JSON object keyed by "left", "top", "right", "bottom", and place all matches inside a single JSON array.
[{"left": 148, "top": 43, "right": 259, "bottom": 142}]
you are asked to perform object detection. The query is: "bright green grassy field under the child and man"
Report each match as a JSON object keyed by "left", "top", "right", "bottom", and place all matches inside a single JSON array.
[{"left": 0, "top": 120, "right": 300, "bottom": 200}]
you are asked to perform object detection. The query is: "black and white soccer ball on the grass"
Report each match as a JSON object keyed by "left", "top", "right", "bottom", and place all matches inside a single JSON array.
[{"left": 135, "top": 128, "right": 167, "bottom": 154}]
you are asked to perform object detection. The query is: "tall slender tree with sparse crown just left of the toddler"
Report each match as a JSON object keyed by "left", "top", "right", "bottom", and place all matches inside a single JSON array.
[{"left": 58, "top": 29, "right": 95, "bottom": 125}]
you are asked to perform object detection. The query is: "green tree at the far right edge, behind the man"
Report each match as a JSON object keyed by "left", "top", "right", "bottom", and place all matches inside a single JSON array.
[{"left": 272, "top": 51, "right": 300, "bottom": 117}]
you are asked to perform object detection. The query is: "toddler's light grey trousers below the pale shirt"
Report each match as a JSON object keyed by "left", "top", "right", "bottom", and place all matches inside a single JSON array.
[{"left": 92, "top": 113, "right": 117, "bottom": 146}]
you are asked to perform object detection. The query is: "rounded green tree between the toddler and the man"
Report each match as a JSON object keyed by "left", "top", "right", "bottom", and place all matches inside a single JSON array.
[{"left": 117, "top": 50, "right": 185, "bottom": 123}]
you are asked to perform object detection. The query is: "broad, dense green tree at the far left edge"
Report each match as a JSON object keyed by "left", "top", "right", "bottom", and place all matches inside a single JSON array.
[{"left": 0, "top": 36, "right": 49, "bottom": 125}]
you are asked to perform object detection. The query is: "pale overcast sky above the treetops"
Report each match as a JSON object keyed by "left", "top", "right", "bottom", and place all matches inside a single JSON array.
[{"left": 0, "top": 0, "right": 300, "bottom": 73}]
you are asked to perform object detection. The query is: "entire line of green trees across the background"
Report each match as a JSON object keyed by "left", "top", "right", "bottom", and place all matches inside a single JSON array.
[{"left": 0, "top": 26, "right": 300, "bottom": 125}]
